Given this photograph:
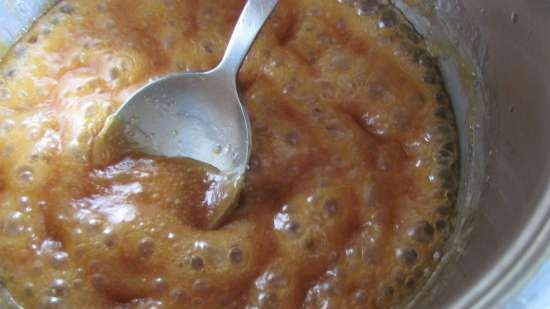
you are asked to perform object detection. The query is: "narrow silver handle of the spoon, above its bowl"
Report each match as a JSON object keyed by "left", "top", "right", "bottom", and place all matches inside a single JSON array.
[{"left": 216, "top": 0, "right": 279, "bottom": 80}]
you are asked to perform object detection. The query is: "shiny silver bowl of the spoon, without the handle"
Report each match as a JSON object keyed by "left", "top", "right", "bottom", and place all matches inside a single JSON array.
[{"left": 115, "top": 69, "right": 251, "bottom": 174}]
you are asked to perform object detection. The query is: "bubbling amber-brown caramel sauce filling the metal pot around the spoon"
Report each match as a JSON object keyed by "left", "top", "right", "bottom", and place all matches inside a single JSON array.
[{"left": 0, "top": 0, "right": 458, "bottom": 309}]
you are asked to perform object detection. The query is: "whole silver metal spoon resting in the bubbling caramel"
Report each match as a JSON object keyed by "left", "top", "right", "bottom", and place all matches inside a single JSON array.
[{"left": 100, "top": 0, "right": 279, "bottom": 228}]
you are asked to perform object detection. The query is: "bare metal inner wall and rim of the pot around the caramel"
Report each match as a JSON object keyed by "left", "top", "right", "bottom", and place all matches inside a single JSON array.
[{"left": 0, "top": 0, "right": 550, "bottom": 309}]
